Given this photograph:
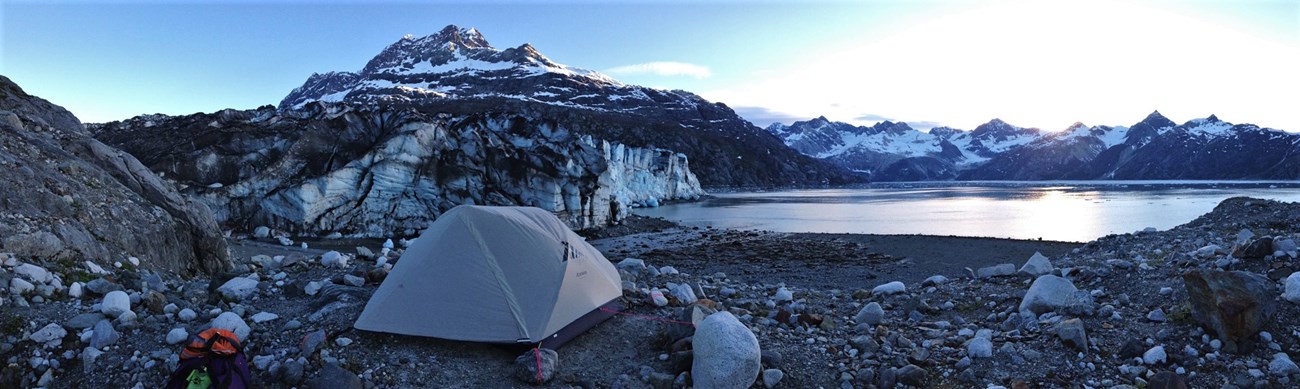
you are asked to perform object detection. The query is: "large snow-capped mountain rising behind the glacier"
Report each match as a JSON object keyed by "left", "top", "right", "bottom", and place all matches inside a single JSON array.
[{"left": 280, "top": 26, "right": 865, "bottom": 186}]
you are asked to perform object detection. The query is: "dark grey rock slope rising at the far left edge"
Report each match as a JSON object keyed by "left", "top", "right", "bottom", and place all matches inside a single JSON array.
[{"left": 0, "top": 77, "right": 230, "bottom": 273}]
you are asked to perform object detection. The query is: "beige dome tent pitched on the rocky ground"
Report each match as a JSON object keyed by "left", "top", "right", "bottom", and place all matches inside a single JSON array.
[{"left": 354, "top": 206, "right": 623, "bottom": 349}]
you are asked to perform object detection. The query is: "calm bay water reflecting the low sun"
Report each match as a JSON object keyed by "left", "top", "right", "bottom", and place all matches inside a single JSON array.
[{"left": 634, "top": 181, "right": 1300, "bottom": 242}]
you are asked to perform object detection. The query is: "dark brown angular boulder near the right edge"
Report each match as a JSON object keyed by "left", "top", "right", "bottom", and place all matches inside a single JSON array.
[{"left": 1183, "top": 269, "right": 1277, "bottom": 353}]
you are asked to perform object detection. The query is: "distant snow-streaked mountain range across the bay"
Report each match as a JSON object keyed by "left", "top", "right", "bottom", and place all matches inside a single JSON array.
[{"left": 767, "top": 112, "right": 1300, "bottom": 181}]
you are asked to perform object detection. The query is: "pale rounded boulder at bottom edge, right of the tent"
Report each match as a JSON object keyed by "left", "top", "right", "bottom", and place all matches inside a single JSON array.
[{"left": 690, "top": 311, "right": 762, "bottom": 389}]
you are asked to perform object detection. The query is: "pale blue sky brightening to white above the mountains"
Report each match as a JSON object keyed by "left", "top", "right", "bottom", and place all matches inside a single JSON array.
[{"left": 0, "top": 0, "right": 1300, "bottom": 131}]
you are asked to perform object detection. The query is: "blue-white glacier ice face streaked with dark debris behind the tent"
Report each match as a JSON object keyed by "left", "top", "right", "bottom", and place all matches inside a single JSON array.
[{"left": 91, "top": 107, "right": 703, "bottom": 237}]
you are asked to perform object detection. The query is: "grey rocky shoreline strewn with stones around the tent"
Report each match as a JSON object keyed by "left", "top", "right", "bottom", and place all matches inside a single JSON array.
[{"left": 0, "top": 198, "right": 1300, "bottom": 388}]
